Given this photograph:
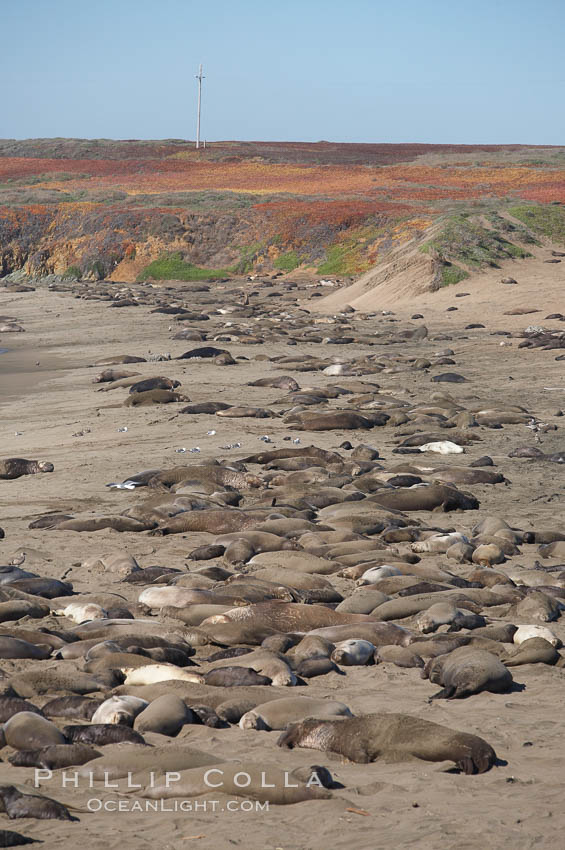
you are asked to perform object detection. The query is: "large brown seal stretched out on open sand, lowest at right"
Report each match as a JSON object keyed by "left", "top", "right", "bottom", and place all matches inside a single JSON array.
[{"left": 277, "top": 713, "right": 496, "bottom": 774}]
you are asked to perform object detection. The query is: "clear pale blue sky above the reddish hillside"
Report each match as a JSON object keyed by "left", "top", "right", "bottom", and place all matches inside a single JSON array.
[{"left": 0, "top": 0, "right": 565, "bottom": 144}]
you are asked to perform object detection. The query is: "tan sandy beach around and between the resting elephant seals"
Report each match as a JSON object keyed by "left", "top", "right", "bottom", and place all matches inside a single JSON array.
[{"left": 0, "top": 250, "right": 565, "bottom": 850}]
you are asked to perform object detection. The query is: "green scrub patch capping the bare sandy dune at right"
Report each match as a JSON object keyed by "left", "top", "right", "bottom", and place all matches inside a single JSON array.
[{"left": 420, "top": 213, "right": 532, "bottom": 269}]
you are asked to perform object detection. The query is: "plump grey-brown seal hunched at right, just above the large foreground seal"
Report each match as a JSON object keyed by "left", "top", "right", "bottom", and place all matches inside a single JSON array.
[{"left": 422, "top": 646, "right": 513, "bottom": 699}]
